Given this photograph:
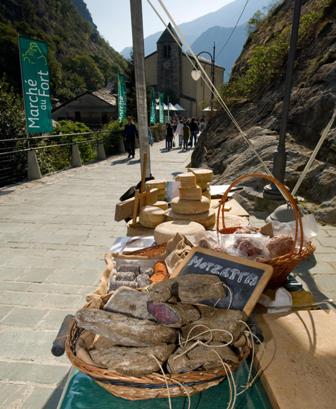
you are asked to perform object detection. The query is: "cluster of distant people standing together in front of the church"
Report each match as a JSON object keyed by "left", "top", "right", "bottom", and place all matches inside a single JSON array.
[{"left": 166, "top": 118, "right": 206, "bottom": 151}]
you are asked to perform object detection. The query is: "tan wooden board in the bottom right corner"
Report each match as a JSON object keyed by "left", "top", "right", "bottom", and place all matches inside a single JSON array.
[{"left": 257, "top": 310, "right": 336, "bottom": 409}]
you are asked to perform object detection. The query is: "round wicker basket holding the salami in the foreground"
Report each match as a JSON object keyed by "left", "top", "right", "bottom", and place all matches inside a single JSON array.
[{"left": 65, "top": 295, "right": 251, "bottom": 400}]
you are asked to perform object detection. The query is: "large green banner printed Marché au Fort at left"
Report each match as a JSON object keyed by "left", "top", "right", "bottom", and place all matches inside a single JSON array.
[{"left": 19, "top": 36, "right": 52, "bottom": 134}]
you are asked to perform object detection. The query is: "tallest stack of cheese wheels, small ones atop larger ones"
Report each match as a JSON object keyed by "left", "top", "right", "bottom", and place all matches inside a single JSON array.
[{"left": 166, "top": 172, "right": 216, "bottom": 229}]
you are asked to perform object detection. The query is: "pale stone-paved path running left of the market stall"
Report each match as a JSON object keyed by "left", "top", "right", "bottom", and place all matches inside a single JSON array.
[{"left": 0, "top": 143, "right": 190, "bottom": 409}]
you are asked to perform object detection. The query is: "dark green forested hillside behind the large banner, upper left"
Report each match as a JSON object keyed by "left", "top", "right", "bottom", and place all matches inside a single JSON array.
[{"left": 0, "top": 0, "right": 127, "bottom": 102}]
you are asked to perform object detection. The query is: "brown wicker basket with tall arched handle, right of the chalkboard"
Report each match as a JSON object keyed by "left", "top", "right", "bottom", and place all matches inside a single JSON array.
[{"left": 217, "top": 173, "right": 315, "bottom": 288}]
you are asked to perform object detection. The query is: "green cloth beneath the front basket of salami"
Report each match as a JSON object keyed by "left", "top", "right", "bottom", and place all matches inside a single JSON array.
[{"left": 60, "top": 363, "right": 272, "bottom": 409}]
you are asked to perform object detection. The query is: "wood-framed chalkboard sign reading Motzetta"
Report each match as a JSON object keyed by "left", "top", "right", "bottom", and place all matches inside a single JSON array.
[{"left": 174, "top": 247, "right": 273, "bottom": 315}]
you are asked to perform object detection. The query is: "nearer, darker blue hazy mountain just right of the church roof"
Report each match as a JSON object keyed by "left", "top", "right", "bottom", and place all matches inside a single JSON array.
[{"left": 192, "top": 24, "right": 247, "bottom": 81}]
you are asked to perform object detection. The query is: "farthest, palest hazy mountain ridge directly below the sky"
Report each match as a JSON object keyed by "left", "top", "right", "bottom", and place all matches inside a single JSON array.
[{"left": 121, "top": 0, "right": 275, "bottom": 58}]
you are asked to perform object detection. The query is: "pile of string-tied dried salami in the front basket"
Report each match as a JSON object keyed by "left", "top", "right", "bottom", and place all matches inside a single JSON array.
[{"left": 76, "top": 274, "right": 248, "bottom": 376}]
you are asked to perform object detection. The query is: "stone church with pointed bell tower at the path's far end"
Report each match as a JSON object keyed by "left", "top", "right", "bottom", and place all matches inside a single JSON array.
[{"left": 145, "top": 24, "right": 224, "bottom": 117}]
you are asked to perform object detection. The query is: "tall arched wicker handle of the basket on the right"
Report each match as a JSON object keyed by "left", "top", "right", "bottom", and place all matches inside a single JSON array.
[{"left": 217, "top": 172, "right": 303, "bottom": 253}]
